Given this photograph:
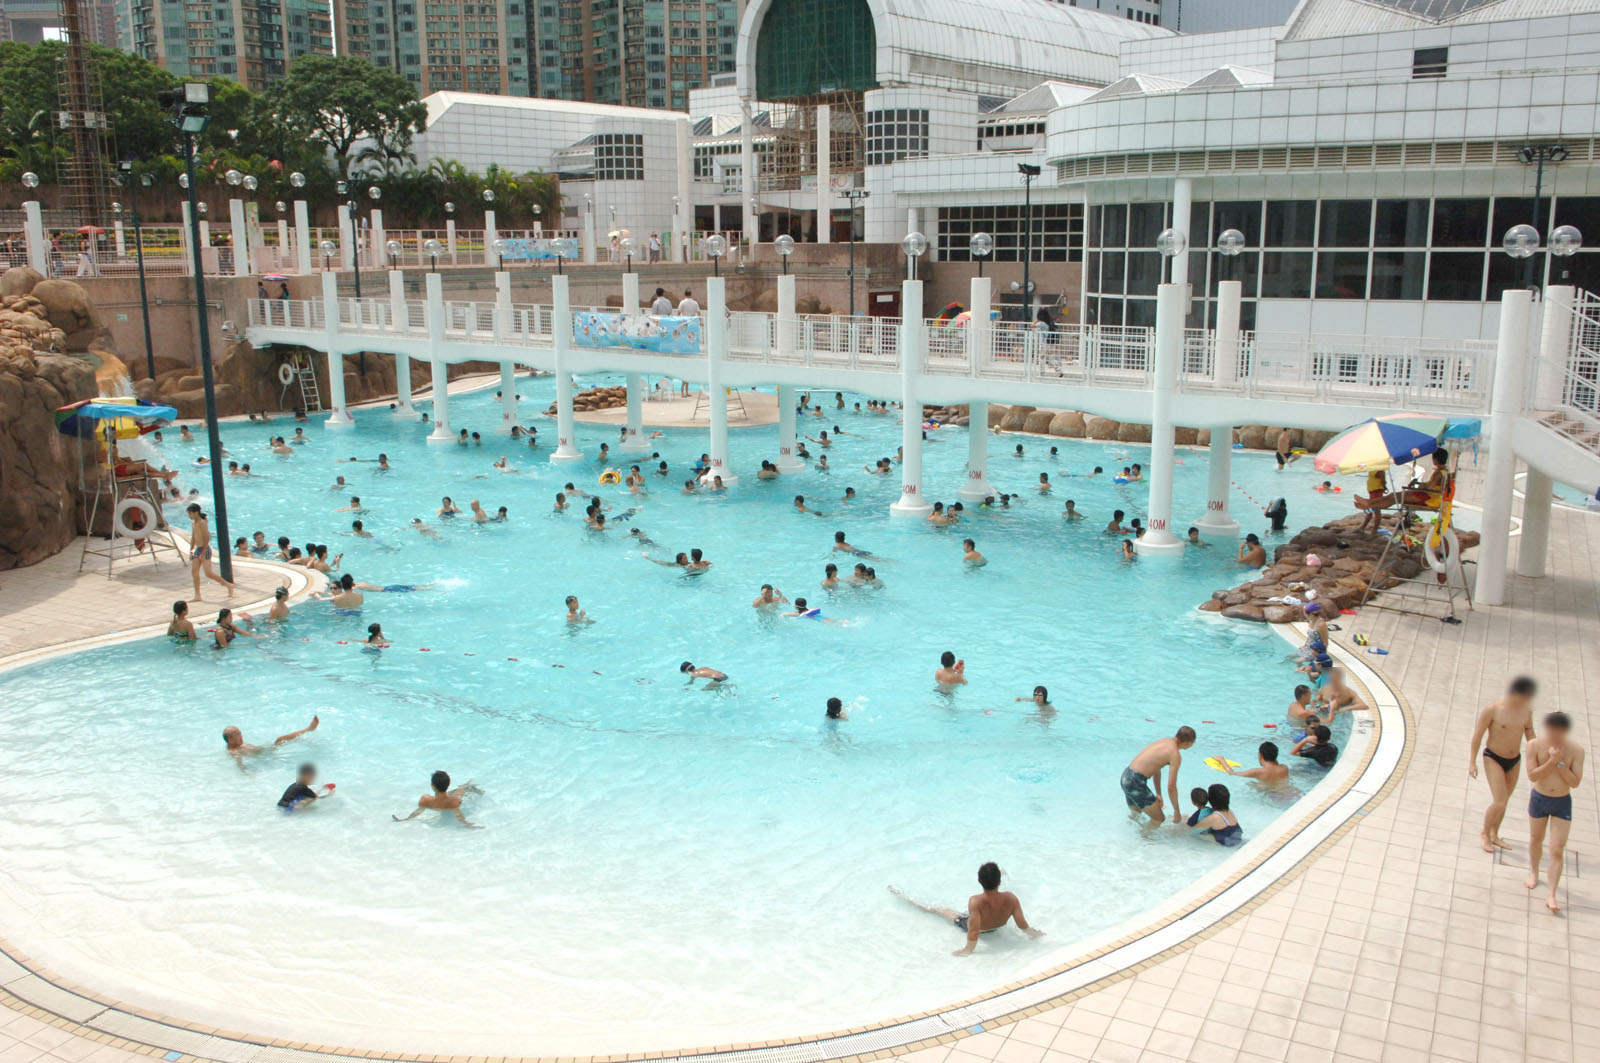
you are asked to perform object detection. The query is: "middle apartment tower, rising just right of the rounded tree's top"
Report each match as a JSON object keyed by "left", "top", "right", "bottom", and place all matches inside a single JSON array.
[{"left": 333, "top": 0, "right": 533, "bottom": 96}]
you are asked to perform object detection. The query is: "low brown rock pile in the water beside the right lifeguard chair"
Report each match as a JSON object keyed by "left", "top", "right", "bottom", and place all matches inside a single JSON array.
[{"left": 1200, "top": 514, "right": 1478, "bottom": 624}]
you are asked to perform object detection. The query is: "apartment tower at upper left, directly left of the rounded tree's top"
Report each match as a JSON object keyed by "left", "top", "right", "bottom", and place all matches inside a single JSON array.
[{"left": 118, "top": 0, "right": 333, "bottom": 91}]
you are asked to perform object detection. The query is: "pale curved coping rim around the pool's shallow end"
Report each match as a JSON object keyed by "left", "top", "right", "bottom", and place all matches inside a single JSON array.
[{"left": 0, "top": 611, "right": 1414, "bottom": 1063}]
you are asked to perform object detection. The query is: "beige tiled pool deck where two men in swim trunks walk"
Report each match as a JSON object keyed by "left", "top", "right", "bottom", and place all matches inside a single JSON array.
[{"left": 0, "top": 475, "right": 1600, "bottom": 1063}]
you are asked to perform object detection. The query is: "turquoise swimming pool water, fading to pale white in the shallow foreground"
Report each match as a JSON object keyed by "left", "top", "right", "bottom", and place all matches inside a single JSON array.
[{"left": 0, "top": 378, "right": 1349, "bottom": 1055}]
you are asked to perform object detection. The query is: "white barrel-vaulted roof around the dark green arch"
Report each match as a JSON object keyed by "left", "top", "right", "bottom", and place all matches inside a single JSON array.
[{"left": 738, "top": 0, "right": 1173, "bottom": 99}]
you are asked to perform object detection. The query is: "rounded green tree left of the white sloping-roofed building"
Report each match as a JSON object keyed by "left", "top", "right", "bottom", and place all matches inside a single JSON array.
[{"left": 260, "top": 56, "right": 427, "bottom": 176}]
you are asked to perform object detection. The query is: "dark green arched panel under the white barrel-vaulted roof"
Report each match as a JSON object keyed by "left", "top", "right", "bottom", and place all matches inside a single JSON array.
[{"left": 755, "top": 0, "right": 878, "bottom": 101}]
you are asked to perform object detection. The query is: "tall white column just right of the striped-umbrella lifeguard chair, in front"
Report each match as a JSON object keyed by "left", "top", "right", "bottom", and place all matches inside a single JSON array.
[{"left": 1474, "top": 288, "right": 1533, "bottom": 605}]
